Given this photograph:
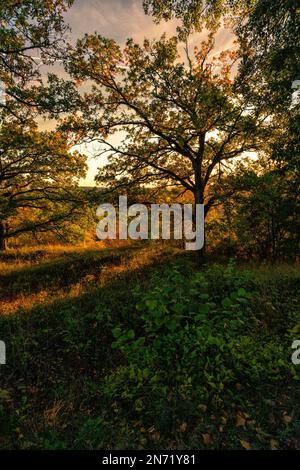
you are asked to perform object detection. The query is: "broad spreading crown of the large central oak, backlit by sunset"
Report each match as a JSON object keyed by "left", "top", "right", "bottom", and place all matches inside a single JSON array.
[{"left": 63, "top": 35, "right": 269, "bottom": 226}]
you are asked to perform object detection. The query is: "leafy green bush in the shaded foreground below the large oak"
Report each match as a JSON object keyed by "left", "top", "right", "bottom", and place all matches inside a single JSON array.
[{"left": 103, "top": 263, "right": 291, "bottom": 429}]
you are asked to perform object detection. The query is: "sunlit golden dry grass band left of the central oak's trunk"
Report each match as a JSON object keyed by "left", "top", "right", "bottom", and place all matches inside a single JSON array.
[{"left": 0, "top": 243, "right": 179, "bottom": 315}]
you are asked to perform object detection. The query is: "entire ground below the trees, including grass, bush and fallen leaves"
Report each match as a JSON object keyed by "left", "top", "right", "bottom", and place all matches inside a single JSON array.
[{"left": 0, "top": 243, "right": 300, "bottom": 449}]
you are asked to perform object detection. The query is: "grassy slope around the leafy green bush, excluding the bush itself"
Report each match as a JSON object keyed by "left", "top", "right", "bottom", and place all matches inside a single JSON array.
[{"left": 0, "top": 244, "right": 300, "bottom": 449}]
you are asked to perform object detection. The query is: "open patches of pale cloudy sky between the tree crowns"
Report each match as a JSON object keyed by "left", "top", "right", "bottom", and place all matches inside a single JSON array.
[{"left": 61, "top": 0, "right": 233, "bottom": 186}]
